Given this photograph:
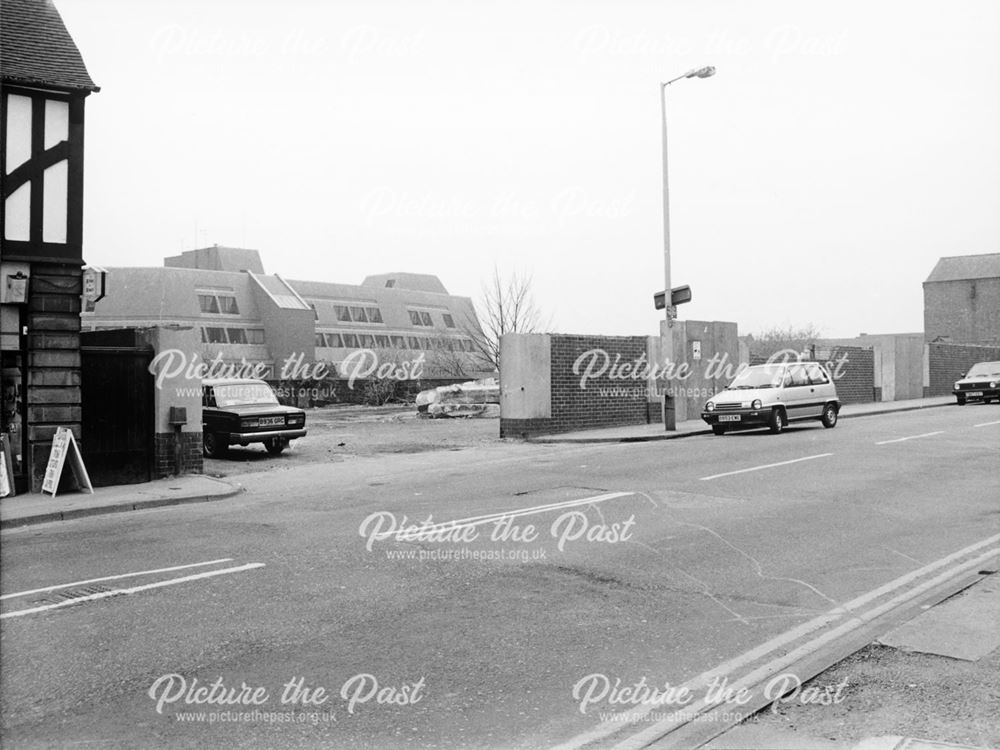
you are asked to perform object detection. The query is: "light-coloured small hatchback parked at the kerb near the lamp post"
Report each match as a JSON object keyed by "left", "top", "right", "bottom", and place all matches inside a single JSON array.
[{"left": 701, "top": 362, "right": 840, "bottom": 435}]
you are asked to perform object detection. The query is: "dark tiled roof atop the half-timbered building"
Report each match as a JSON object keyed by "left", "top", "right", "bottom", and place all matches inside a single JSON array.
[{"left": 0, "top": 0, "right": 100, "bottom": 91}]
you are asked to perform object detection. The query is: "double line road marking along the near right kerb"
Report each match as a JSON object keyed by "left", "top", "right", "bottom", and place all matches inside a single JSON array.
[{"left": 553, "top": 534, "right": 1000, "bottom": 750}]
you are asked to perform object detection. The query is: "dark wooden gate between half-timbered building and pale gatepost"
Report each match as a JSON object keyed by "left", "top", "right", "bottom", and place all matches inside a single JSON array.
[{"left": 80, "top": 329, "right": 154, "bottom": 487}]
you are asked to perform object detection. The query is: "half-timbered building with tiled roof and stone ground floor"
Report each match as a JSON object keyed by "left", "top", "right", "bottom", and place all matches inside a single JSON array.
[{"left": 0, "top": 0, "right": 98, "bottom": 491}]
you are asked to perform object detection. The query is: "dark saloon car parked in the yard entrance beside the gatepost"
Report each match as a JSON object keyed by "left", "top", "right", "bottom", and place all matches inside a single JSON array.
[{"left": 202, "top": 379, "right": 306, "bottom": 457}]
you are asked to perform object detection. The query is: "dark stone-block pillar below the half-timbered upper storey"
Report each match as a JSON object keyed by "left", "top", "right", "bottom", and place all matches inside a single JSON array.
[{"left": 26, "top": 263, "right": 82, "bottom": 492}]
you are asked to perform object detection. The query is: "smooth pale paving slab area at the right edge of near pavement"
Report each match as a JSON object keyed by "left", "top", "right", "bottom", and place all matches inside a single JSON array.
[{"left": 879, "top": 576, "right": 1000, "bottom": 661}]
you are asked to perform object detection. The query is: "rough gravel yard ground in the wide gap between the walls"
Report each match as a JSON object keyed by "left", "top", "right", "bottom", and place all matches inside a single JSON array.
[{"left": 204, "top": 405, "right": 500, "bottom": 477}]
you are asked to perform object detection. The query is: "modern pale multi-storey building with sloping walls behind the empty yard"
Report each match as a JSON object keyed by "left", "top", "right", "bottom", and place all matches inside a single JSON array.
[{"left": 82, "top": 246, "right": 491, "bottom": 379}]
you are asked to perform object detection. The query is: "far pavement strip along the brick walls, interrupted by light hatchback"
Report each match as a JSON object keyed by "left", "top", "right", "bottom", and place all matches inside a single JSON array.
[{"left": 528, "top": 396, "right": 955, "bottom": 443}]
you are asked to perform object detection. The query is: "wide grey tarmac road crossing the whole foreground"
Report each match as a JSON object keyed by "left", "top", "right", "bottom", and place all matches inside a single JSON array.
[{"left": 0, "top": 405, "right": 1000, "bottom": 748}]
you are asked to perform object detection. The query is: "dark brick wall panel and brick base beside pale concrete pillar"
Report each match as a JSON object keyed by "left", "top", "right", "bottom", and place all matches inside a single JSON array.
[{"left": 500, "top": 335, "right": 658, "bottom": 438}]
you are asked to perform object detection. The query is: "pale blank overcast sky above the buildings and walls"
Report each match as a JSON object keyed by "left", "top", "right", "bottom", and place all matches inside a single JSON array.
[{"left": 56, "top": 0, "right": 1000, "bottom": 336}]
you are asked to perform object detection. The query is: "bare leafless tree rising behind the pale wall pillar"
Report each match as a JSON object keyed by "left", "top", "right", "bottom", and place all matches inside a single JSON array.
[{"left": 465, "top": 266, "right": 549, "bottom": 370}]
